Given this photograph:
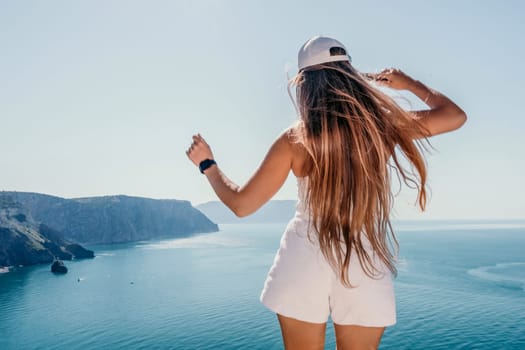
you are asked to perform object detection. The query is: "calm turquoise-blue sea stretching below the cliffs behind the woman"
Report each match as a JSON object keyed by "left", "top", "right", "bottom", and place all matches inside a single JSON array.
[{"left": 0, "top": 221, "right": 525, "bottom": 350}]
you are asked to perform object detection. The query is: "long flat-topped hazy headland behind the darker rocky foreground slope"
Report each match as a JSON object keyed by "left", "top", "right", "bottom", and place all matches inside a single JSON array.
[{"left": 4, "top": 192, "right": 218, "bottom": 243}]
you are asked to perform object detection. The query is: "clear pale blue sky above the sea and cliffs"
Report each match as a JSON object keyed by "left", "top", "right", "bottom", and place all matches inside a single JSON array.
[{"left": 0, "top": 0, "right": 525, "bottom": 219}]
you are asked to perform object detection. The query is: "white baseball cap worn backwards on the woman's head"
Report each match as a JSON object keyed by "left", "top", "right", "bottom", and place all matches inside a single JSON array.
[{"left": 298, "top": 35, "right": 352, "bottom": 70}]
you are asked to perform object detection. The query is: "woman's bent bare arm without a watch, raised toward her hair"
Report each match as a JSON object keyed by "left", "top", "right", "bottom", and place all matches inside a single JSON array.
[{"left": 375, "top": 68, "right": 467, "bottom": 137}]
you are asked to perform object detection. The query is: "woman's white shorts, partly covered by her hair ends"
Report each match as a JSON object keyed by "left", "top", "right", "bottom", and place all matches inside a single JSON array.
[{"left": 260, "top": 217, "right": 396, "bottom": 327}]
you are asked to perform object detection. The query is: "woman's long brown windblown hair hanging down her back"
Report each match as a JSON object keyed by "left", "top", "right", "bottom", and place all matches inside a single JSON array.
[{"left": 290, "top": 62, "right": 428, "bottom": 287}]
